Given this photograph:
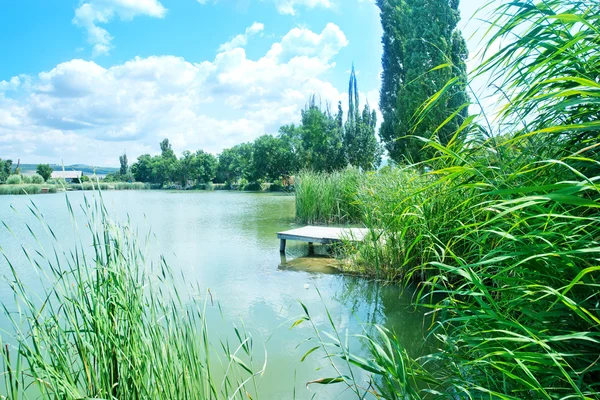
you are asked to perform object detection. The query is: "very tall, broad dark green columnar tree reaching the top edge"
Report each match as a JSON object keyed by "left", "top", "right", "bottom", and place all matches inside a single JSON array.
[{"left": 377, "top": 0, "right": 468, "bottom": 162}]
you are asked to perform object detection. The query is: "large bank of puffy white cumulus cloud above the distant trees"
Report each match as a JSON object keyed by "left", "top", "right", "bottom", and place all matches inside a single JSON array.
[{"left": 0, "top": 24, "right": 366, "bottom": 165}]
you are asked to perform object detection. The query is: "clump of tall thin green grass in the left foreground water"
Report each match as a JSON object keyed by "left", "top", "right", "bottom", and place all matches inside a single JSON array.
[{"left": 1, "top": 194, "right": 264, "bottom": 400}]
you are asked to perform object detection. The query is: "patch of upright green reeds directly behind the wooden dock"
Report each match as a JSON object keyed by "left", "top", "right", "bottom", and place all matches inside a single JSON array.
[{"left": 295, "top": 168, "right": 362, "bottom": 224}]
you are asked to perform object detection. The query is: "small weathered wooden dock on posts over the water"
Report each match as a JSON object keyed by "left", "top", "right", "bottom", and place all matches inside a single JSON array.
[{"left": 277, "top": 226, "right": 369, "bottom": 253}]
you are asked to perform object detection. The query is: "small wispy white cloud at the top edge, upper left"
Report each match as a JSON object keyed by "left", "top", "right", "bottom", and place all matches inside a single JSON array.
[{"left": 73, "top": 0, "right": 167, "bottom": 55}]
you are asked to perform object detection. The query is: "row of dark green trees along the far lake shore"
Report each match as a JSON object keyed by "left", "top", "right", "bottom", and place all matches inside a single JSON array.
[{"left": 106, "top": 66, "right": 383, "bottom": 187}]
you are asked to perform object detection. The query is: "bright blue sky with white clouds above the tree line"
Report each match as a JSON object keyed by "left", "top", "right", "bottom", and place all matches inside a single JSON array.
[{"left": 0, "top": 0, "right": 492, "bottom": 166}]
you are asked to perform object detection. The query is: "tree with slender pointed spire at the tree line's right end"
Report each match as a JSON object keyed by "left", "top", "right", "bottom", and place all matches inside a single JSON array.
[{"left": 338, "top": 65, "right": 382, "bottom": 171}]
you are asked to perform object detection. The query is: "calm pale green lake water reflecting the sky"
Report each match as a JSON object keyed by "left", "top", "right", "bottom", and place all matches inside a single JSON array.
[{"left": 0, "top": 191, "right": 432, "bottom": 399}]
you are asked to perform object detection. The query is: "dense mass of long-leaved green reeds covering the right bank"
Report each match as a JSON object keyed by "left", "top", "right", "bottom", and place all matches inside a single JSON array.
[{"left": 298, "top": 0, "right": 600, "bottom": 399}]
